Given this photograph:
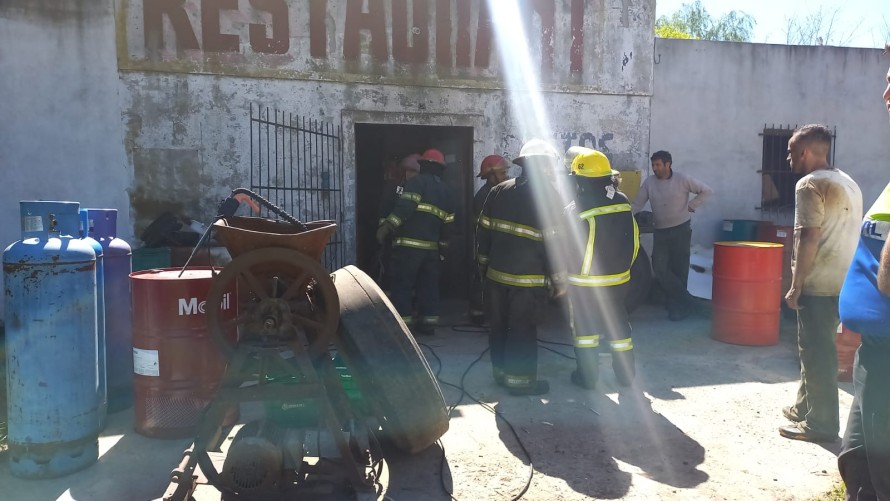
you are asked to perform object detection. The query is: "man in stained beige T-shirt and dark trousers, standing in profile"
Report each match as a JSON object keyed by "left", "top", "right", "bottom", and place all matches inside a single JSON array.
[{"left": 779, "top": 125, "right": 862, "bottom": 442}]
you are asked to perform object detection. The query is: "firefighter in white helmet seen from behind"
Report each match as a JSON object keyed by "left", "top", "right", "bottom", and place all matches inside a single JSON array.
[{"left": 476, "top": 139, "right": 565, "bottom": 395}]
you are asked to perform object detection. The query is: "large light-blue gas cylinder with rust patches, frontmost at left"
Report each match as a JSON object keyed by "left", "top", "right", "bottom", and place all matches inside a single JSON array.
[{"left": 3, "top": 201, "right": 102, "bottom": 478}]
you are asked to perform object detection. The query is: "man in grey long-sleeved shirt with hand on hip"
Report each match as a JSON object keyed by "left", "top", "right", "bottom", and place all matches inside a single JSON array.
[{"left": 632, "top": 151, "right": 714, "bottom": 320}]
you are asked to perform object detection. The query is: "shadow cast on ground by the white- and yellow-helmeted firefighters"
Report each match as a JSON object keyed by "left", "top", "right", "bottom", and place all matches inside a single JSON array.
[{"left": 497, "top": 378, "right": 708, "bottom": 499}]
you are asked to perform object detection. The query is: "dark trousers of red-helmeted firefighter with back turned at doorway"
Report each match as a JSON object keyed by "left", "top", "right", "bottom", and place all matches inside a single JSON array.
[{"left": 389, "top": 246, "right": 441, "bottom": 329}]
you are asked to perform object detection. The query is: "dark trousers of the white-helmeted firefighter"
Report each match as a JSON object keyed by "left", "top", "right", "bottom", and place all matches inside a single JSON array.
[{"left": 485, "top": 280, "right": 547, "bottom": 388}]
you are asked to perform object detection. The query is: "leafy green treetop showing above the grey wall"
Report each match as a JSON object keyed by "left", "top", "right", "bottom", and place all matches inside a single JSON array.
[{"left": 655, "top": 0, "right": 757, "bottom": 42}]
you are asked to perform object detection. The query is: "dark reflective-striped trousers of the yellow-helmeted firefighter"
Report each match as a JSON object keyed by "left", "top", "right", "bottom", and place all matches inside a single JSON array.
[{"left": 568, "top": 283, "right": 635, "bottom": 388}]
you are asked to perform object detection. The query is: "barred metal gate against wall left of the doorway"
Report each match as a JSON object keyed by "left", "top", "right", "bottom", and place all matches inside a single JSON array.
[{"left": 250, "top": 105, "right": 346, "bottom": 270}]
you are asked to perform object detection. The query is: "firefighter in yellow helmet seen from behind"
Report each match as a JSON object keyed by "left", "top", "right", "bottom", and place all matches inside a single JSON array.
[{"left": 567, "top": 146, "right": 640, "bottom": 389}]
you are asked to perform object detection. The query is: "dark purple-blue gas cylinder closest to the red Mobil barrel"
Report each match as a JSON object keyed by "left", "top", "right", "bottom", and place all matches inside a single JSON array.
[{"left": 84, "top": 209, "right": 133, "bottom": 412}]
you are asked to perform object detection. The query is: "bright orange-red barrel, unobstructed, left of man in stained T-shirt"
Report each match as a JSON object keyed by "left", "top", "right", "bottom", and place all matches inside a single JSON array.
[{"left": 711, "top": 242, "right": 783, "bottom": 346}]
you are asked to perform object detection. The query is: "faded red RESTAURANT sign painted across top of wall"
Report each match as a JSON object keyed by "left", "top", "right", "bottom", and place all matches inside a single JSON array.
[{"left": 118, "top": 0, "right": 651, "bottom": 89}]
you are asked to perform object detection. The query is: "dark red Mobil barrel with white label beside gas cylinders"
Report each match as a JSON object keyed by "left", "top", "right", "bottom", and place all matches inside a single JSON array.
[{"left": 130, "top": 267, "right": 238, "bottom": 438}]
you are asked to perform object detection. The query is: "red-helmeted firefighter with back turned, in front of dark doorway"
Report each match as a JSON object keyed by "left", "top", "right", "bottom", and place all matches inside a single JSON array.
[{"left": 377, "top": 149, "right": 454, "bottom": 334}]
